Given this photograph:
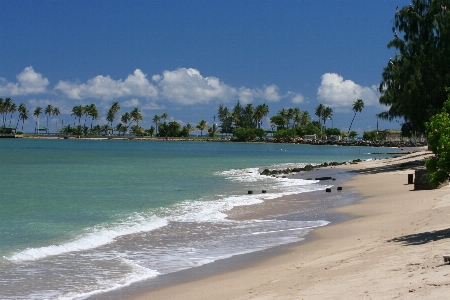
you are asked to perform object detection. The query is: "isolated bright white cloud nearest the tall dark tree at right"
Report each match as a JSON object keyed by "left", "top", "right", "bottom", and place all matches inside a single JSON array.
[{"left": 317, "top": 73, "right": 379, "bottom": 108}]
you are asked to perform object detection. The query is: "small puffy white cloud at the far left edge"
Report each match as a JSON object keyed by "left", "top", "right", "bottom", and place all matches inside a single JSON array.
[{"left": 0, "top": 66, "right": 49, "bottom": 96}]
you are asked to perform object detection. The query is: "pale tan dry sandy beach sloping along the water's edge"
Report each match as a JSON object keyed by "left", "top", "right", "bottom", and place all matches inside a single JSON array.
[{"left": 125, "top": 152, "right": 450, "bottom": 300}]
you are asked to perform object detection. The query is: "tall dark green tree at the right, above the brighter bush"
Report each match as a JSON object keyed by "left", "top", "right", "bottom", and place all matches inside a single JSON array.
[{"left": 379, "top": 0, "right": 450, "bottom": 132}]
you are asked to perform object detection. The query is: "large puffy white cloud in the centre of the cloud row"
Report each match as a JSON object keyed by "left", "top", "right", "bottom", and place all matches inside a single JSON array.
[{"left": 152, "top": 68, "right": 237, "bottom": 105}]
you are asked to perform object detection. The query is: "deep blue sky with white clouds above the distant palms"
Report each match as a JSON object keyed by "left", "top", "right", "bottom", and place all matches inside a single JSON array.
[{"left": 0, "top": 0, "right": 410, "bottom": 134}]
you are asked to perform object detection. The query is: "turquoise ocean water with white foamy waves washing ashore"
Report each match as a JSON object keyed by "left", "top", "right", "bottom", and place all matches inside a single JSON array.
[{"left": 0, "top": 139, "right": 406, "bottom": 299}]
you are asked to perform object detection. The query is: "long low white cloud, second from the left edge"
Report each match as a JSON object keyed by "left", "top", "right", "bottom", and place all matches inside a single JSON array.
[{"left": 55, "top": 69, "right": 158, "bottom": 100}]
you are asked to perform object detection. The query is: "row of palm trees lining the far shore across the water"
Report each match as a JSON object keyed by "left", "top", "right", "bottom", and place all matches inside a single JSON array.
[{"left": 0, "top": 98, "right": 364, "bottom": 136}]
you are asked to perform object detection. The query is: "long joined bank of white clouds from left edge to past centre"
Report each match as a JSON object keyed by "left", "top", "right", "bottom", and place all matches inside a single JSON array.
[{"left": 4, "top": 66, "right": 303, "bottom": 110}]
